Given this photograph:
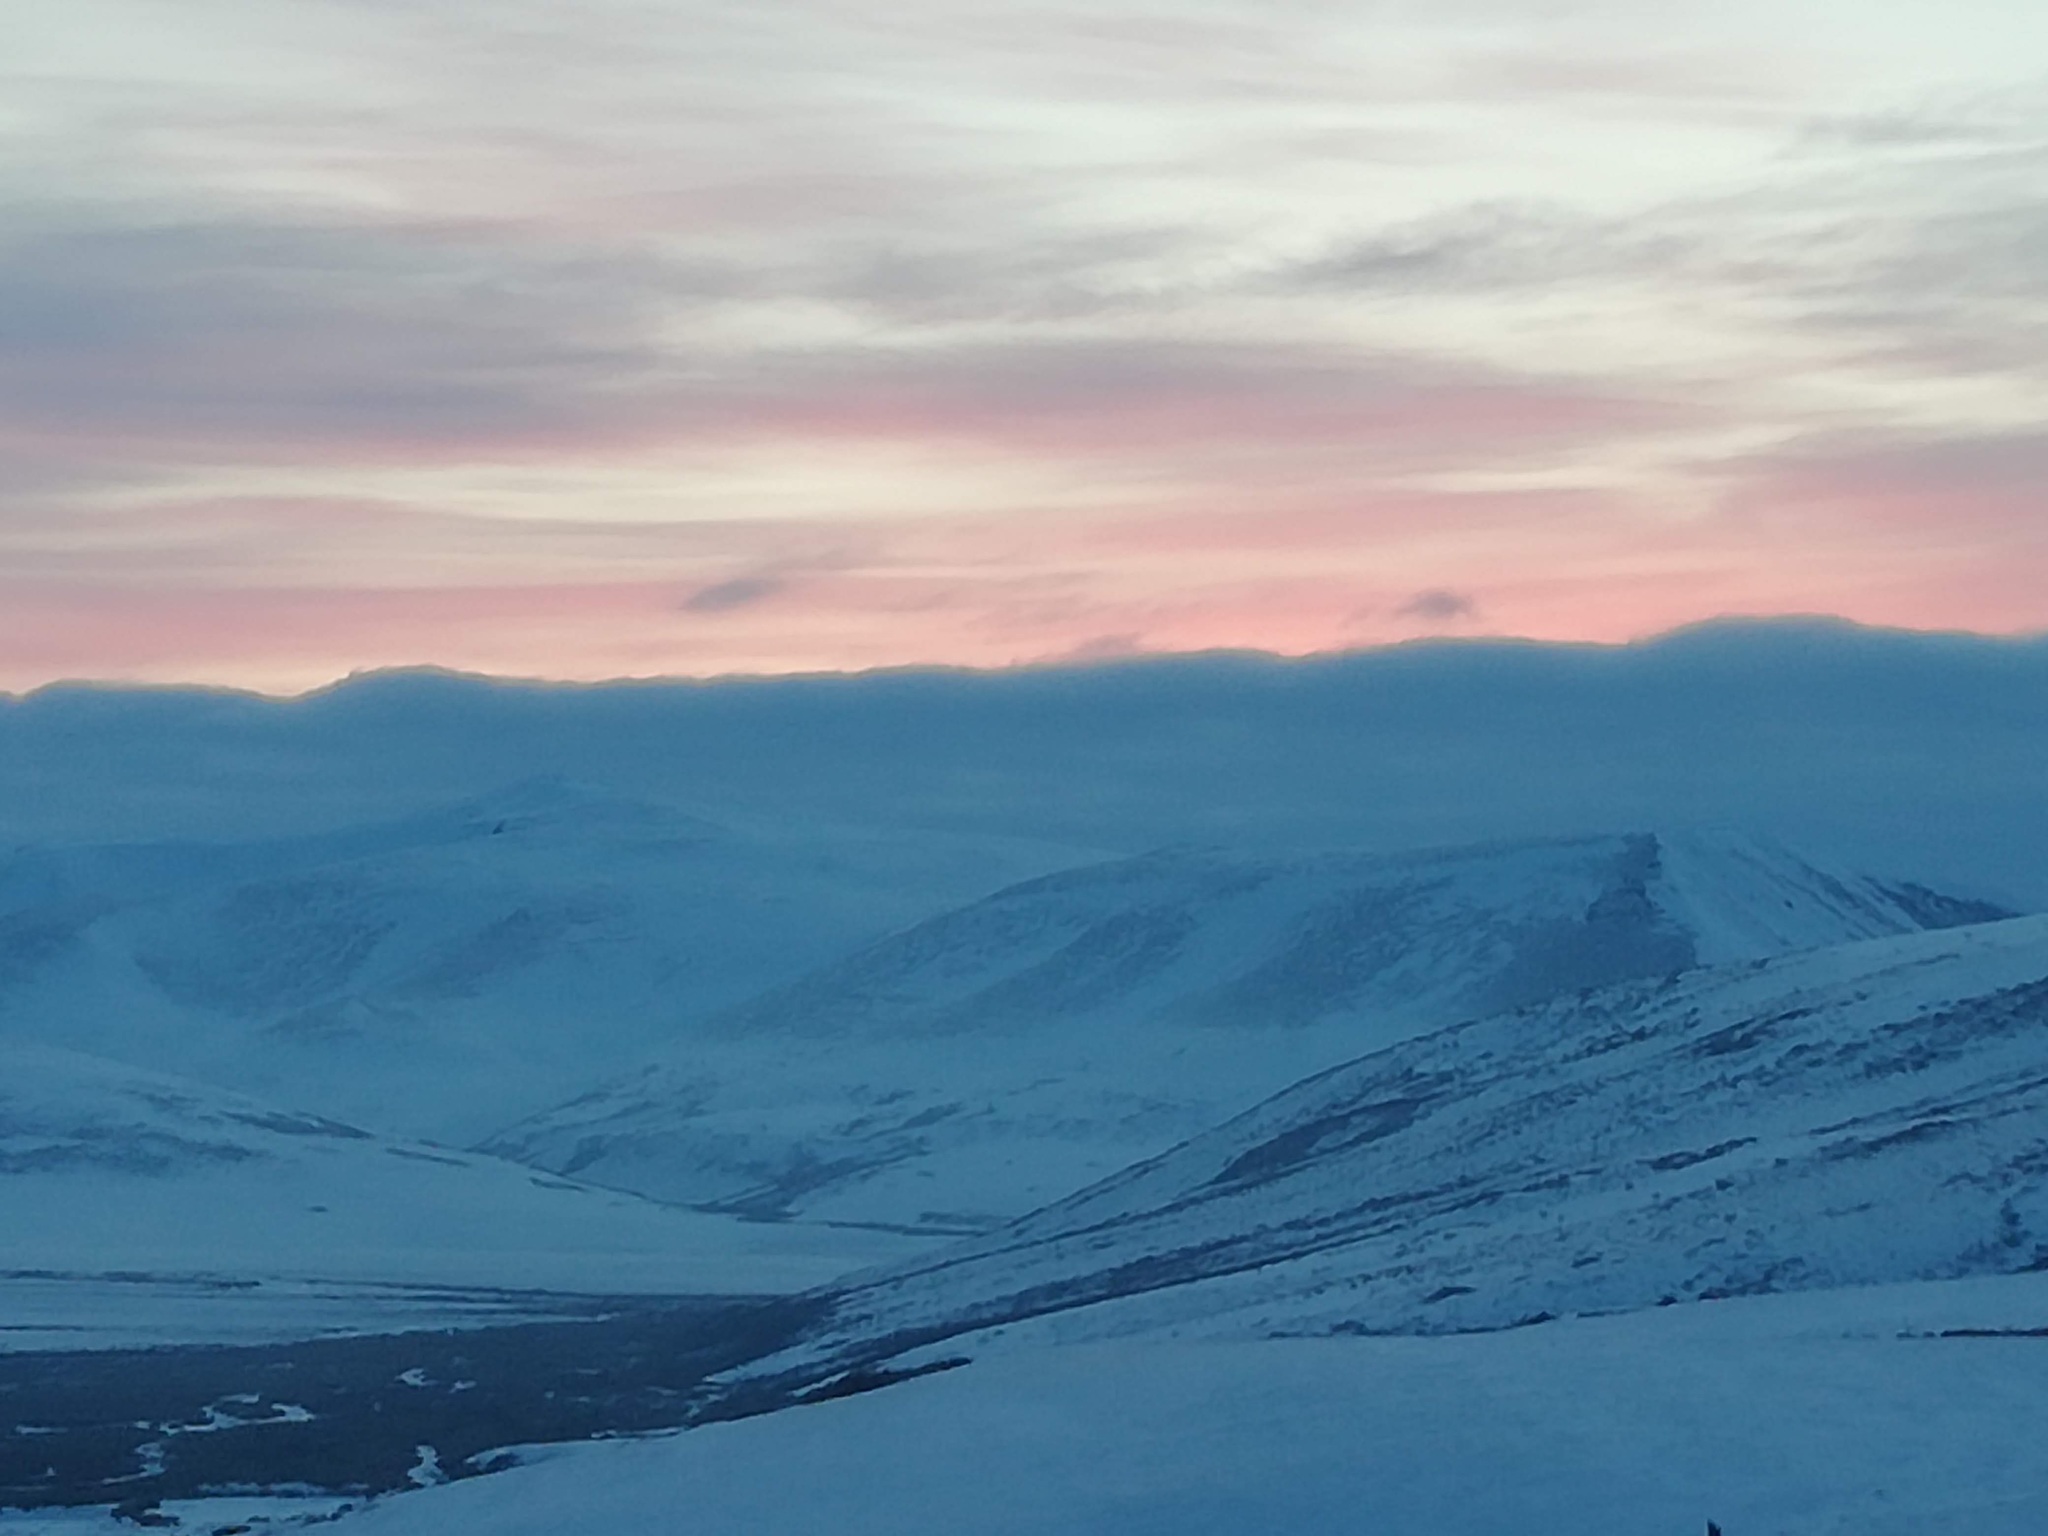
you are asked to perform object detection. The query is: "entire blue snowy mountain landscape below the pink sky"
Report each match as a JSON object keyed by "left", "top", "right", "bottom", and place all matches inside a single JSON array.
[{"left": 0, "top": 623, "right": 2048, "bottom": 1536}]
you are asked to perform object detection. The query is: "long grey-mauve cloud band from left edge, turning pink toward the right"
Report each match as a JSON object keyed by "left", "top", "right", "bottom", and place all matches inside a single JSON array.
[{"left": 0, "top": 187, "right": 1675, "bottom": 501}]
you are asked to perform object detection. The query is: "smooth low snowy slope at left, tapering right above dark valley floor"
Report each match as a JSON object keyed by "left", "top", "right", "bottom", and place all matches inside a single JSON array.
[{"left": 0, "top": 1044, "right": 937, "bottom": 1323}]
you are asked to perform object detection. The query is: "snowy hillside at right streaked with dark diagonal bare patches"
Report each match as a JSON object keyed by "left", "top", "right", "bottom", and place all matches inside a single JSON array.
[{"left": 778, "top": 918, "right": 2048, "bottom": 1356}]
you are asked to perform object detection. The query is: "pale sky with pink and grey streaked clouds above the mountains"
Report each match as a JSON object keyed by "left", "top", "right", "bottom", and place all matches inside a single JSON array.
[{"left": 0, "top": 0, "right": 2048, "bottom": 692}]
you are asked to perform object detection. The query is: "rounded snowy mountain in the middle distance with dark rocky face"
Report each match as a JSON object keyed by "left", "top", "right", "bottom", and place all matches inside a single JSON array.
[{"left": 483, "top": 834, "right": 1991, "bottom": 1227}]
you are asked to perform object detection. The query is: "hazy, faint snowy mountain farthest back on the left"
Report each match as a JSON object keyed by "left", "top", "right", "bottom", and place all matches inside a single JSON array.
[{"left": 0, "top": 780, "right": 1073, "bottom": 1143}]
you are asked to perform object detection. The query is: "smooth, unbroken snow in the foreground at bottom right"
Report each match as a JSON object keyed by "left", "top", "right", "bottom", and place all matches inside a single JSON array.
[{"left": 24, "top": 1276, "right": 2048, "bottom": 1536}]
